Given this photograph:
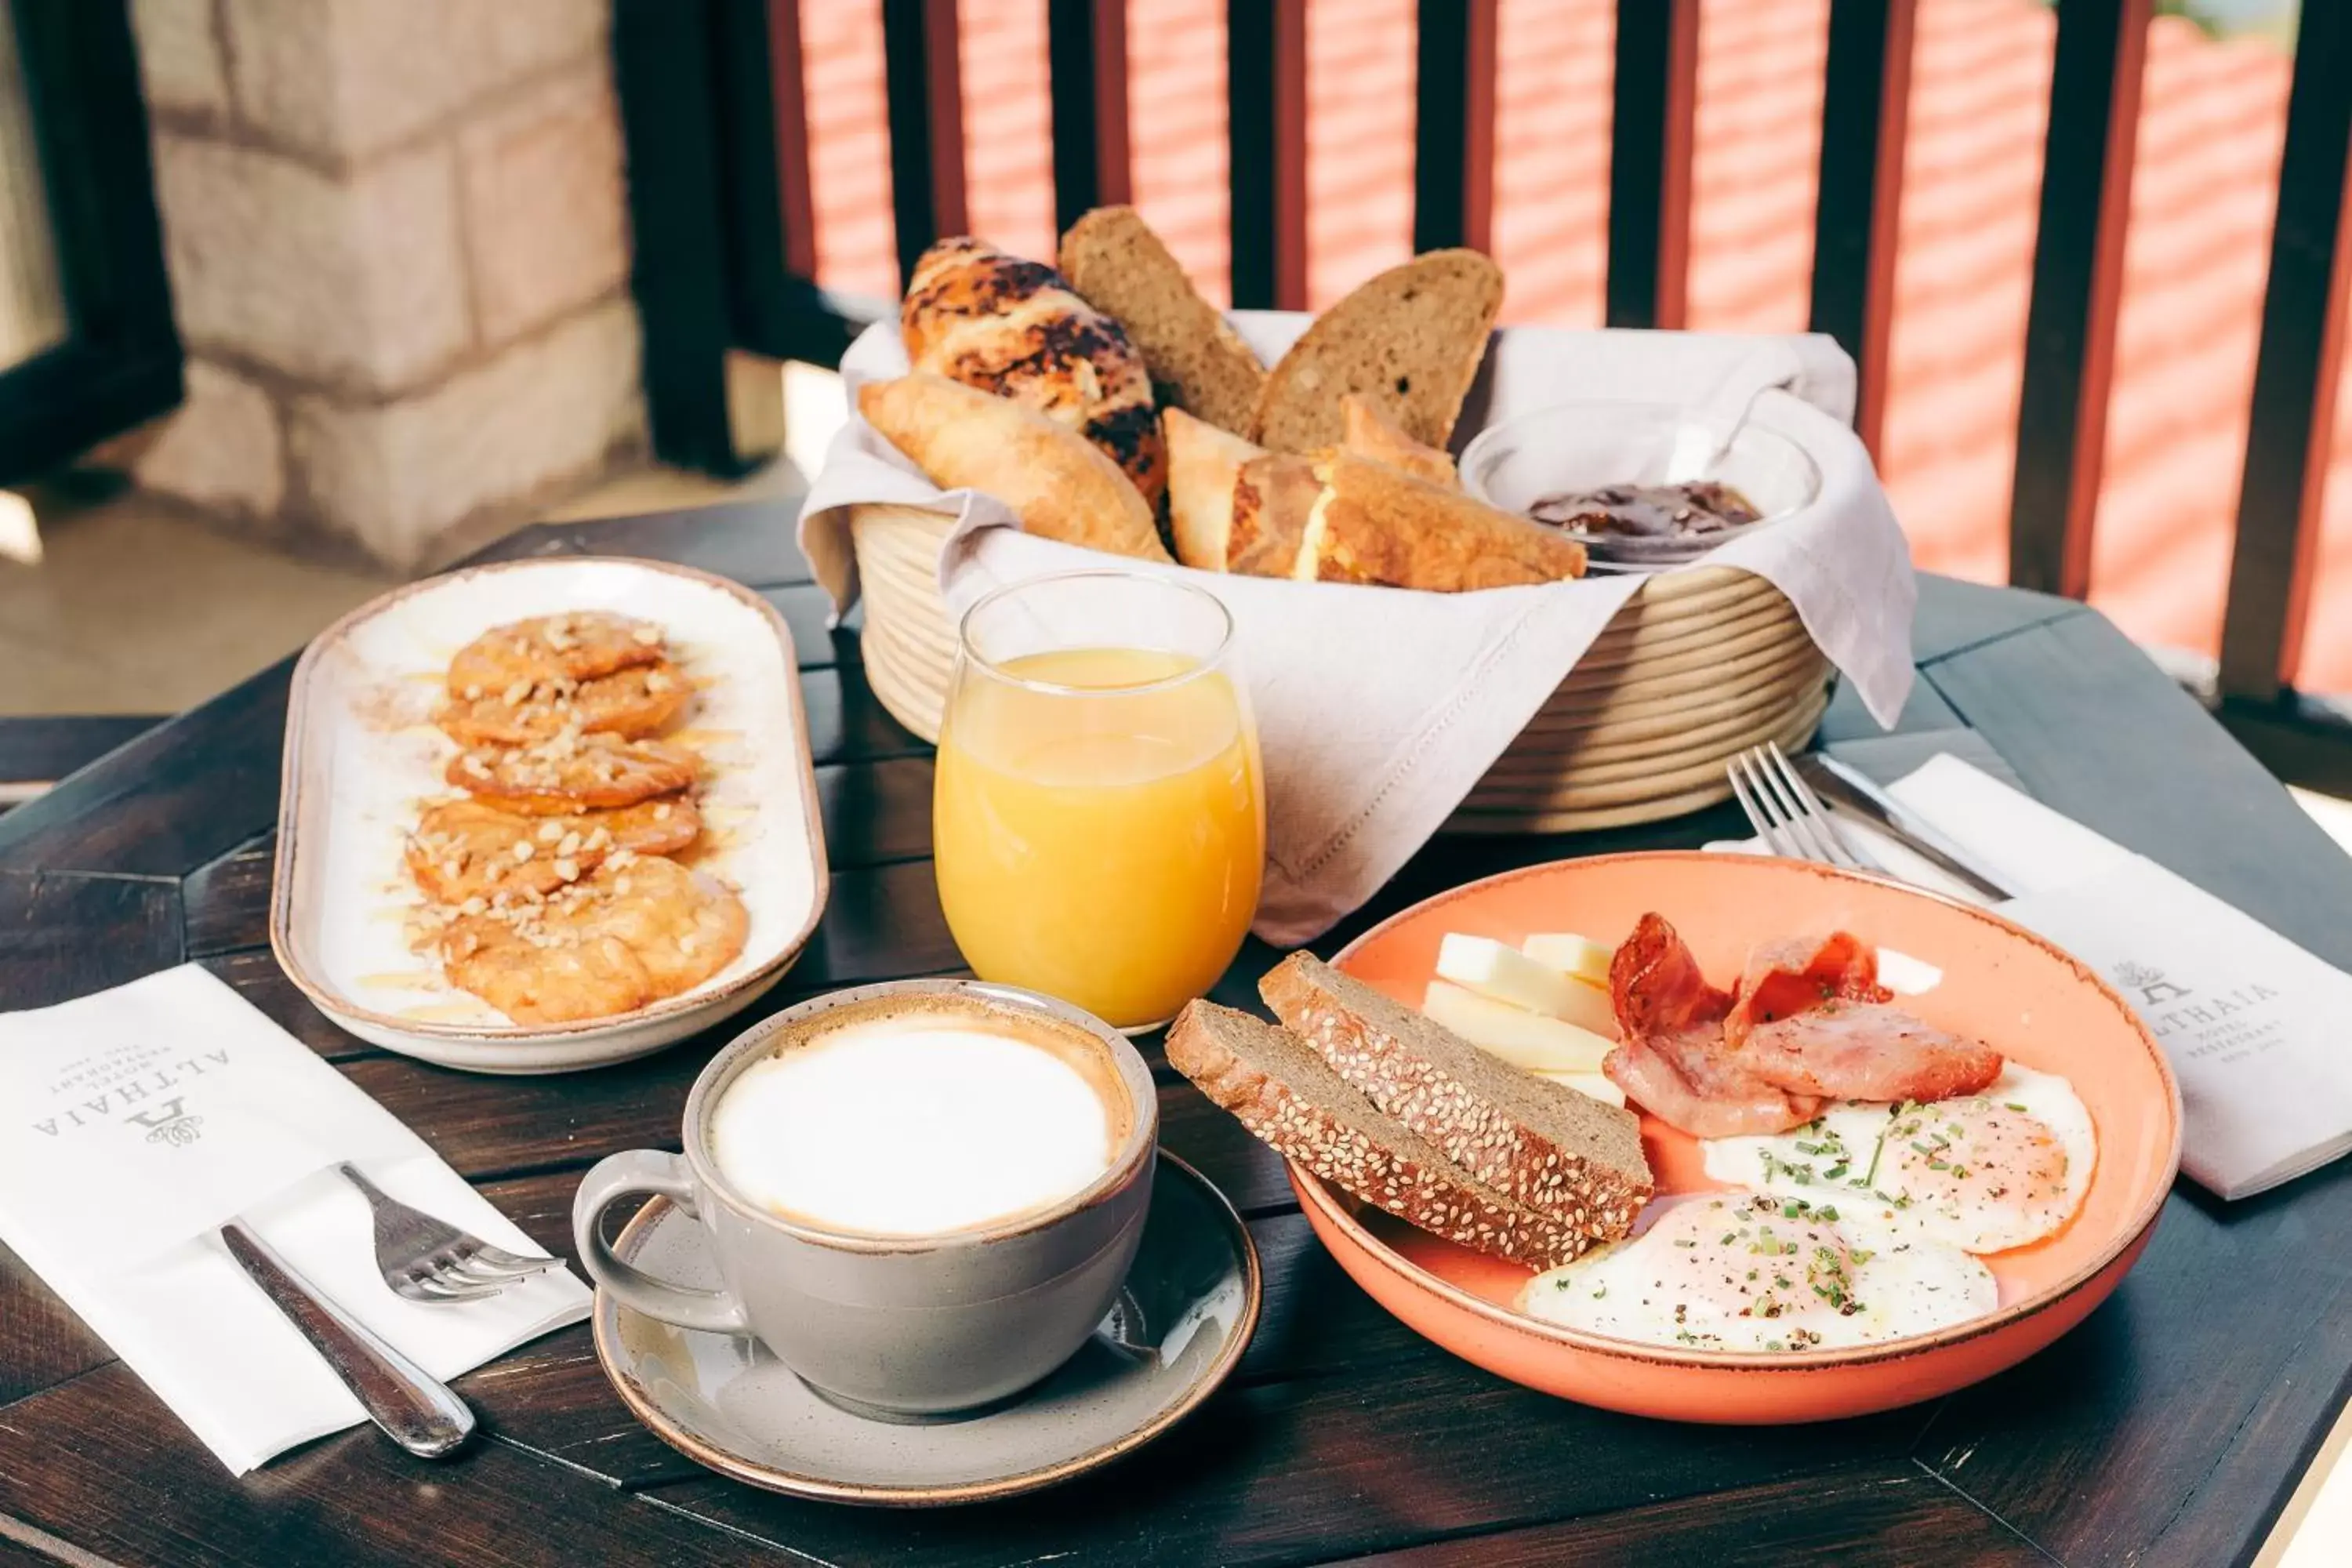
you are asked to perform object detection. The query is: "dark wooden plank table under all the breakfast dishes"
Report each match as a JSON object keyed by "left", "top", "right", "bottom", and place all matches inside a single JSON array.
[{"left": 0, "top": 506, "right": 2352, "bottom": 1568}]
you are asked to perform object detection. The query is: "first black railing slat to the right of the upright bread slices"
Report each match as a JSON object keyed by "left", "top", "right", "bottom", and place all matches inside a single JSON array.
[{"left": 1606, "top": 0, "right": 1698, "bottom": 327}]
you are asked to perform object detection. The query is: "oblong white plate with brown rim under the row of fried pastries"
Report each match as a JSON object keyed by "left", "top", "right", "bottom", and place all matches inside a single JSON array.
[{"left": 270, "top": 557, "right": 826, "bottom": 1072}]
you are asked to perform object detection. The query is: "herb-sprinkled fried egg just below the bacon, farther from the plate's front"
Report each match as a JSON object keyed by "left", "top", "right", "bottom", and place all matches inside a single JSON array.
[{"left": 1705, "top": 1062, "right": 2098, "bottom": 1253}]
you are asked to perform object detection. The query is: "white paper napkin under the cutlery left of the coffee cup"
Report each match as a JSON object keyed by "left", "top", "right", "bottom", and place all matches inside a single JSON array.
[{"left": 0, "top": 964, "right": 590, "bottom": 1474}]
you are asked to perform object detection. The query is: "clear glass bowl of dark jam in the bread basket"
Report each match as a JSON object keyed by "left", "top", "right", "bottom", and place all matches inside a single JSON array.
[{"left": 1461, "top": 402, "right": 1820, "bottom": 572}]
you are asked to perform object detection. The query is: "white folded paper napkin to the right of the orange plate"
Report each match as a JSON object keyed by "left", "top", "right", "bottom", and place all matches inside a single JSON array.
[{"left": 1710, "top": 757, "right": 2352, "bottom": 1199}]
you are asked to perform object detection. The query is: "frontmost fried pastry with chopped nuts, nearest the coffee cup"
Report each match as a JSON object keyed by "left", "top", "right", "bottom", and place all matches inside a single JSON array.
[{"left": 440, "top": 851, "right": 750, "bottom": 1022}]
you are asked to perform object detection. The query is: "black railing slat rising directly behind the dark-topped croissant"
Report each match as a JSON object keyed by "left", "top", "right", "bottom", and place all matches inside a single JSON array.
[{"left": 882, "top": 0, "right": 969, "bottom": 285}]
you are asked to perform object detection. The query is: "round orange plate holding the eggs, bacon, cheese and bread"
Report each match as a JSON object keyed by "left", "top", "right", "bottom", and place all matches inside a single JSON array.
[{"left": 1291, "top": 851, "right": 2180, "bottom": 1425}]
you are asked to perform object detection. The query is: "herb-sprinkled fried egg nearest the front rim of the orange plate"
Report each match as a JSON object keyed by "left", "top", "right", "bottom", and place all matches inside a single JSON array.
[{"left": 1519, "top": 1192, "right": 1999, "bottom": 1352}]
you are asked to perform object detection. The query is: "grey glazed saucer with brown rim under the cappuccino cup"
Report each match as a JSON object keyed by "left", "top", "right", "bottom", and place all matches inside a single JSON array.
[{"left": 595, "top": 1149, "right": 1263, "bottom": 1507}]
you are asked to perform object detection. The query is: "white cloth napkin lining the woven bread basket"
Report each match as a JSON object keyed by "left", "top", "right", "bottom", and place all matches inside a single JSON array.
[{"left": 800, "top": 310, "right": 1917, "bottom": 945}]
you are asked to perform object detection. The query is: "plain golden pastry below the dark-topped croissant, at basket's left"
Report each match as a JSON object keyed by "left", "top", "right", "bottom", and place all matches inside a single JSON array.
[{"left": 858, "top": 372, "right": 1169, "bottom": 562}]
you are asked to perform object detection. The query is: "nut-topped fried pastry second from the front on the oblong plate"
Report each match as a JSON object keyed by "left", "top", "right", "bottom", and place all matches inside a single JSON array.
[{"left": 407, "top": 794, "right": 703, "bottom": 905}]
